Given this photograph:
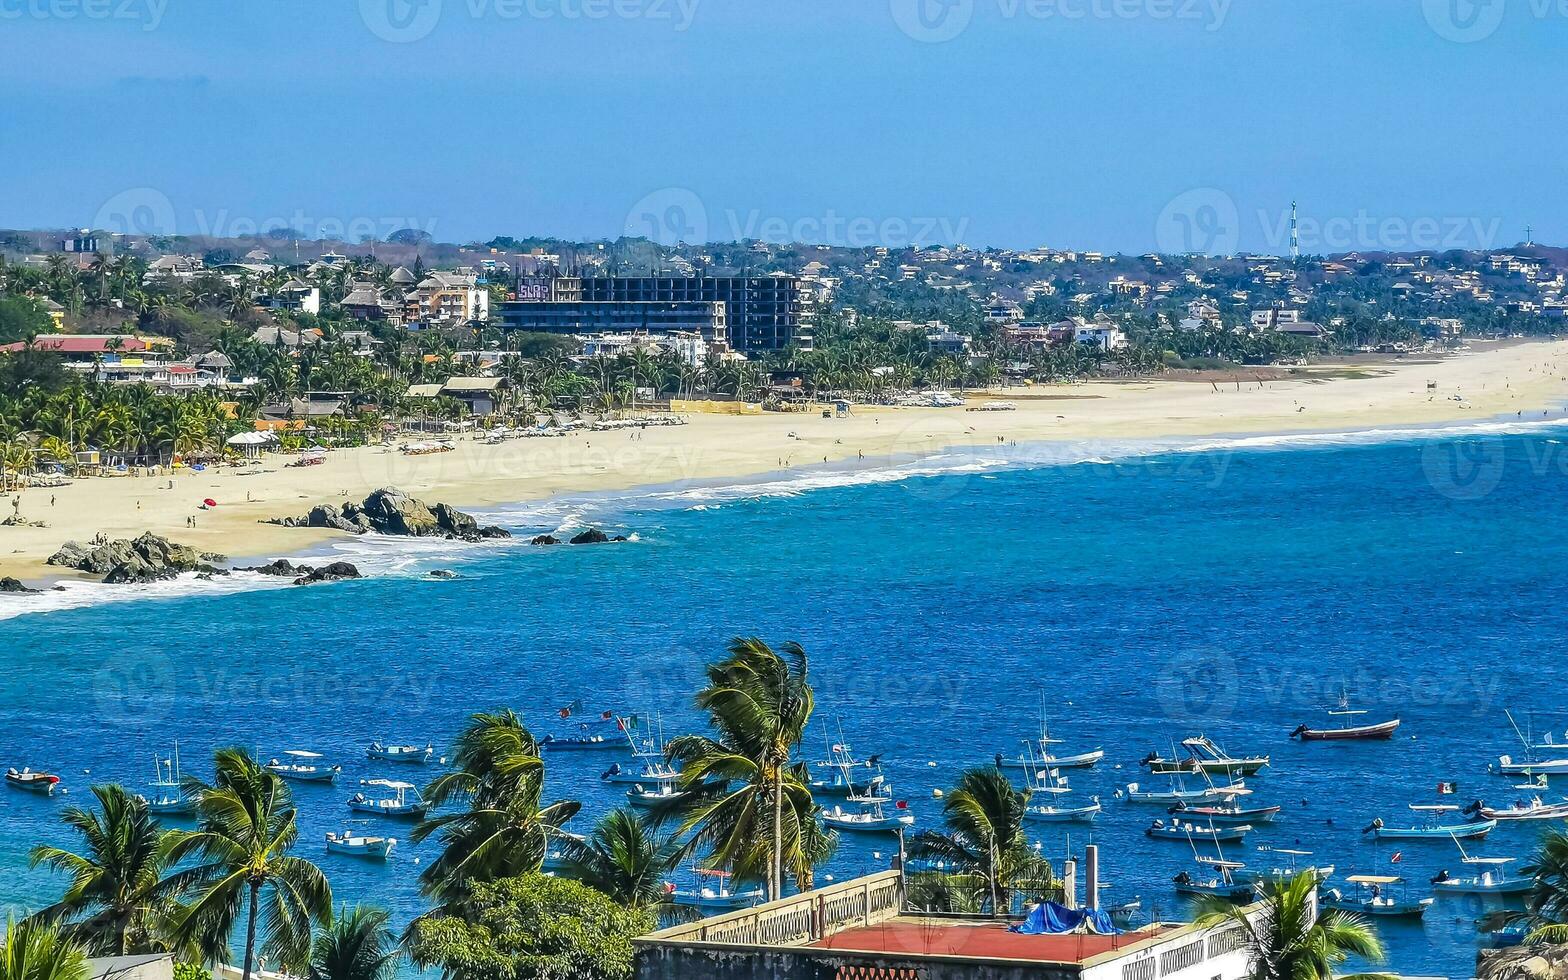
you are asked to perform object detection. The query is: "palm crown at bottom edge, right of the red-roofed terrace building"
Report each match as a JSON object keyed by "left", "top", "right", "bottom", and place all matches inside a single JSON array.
[{"left": 1196, "top": 872, "right": 1389, "bottom": 980}]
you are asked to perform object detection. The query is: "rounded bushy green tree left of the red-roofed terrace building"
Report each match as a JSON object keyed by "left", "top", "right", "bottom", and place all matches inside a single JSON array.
[{"left": 408, "top": 873, "right": 655, "bottom": 980}]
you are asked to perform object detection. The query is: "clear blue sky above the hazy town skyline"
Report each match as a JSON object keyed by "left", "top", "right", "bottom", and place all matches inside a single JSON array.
[{"left": 0, "top": 0, "right": 1568, "bottom": 251}]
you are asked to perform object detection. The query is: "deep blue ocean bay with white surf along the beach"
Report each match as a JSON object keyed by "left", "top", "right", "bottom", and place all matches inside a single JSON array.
[{"left": 0, "top": 425, "right": 1568, "bottom": 975}]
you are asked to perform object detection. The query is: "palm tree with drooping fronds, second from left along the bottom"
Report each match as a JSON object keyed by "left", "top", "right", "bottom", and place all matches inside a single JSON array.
[{"left": 169, "top": 748, "right": 332, "bottom": 980}]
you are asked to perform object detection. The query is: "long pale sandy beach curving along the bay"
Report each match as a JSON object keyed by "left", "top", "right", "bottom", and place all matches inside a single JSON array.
[{"left": 0, "top": 342, "right": 1568, "bottom": 583}]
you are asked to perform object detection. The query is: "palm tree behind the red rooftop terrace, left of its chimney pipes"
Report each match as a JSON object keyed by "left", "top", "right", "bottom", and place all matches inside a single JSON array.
[{"left": 911, "top": 765, "right": 1052, "bottom": 914}]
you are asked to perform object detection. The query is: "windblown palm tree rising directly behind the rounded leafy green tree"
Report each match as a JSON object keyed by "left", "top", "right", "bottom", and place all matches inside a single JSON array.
[{"left": 412, "top": 709, "right": 582, "bottom": 905}]
